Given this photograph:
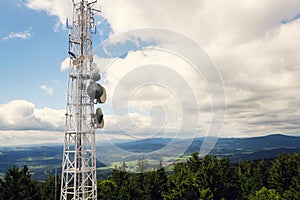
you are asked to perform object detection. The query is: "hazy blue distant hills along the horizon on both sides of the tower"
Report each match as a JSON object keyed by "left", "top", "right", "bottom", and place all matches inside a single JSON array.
[{"left": 0, "top": 134, "right": 300, "bottom": 179}]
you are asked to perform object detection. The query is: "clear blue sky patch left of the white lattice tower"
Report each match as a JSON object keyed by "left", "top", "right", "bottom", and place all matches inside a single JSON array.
[{"left": 0, "top": 1, "right": 68, "bottom": 109}]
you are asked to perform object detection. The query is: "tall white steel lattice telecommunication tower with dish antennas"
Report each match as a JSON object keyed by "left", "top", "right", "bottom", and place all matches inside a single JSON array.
[{"left": 60, "top": 0, "right": 106, "bottom": 200}]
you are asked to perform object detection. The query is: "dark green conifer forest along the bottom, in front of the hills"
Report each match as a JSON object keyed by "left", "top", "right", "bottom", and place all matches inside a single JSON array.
[{"left": 0, "top": 153, "right": 300, "bottom": 200}]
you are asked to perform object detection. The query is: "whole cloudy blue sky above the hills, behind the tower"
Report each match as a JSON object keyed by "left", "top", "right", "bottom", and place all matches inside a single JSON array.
[{"left": 0, "top": 0, "right": 300, "bottom": 146}]
